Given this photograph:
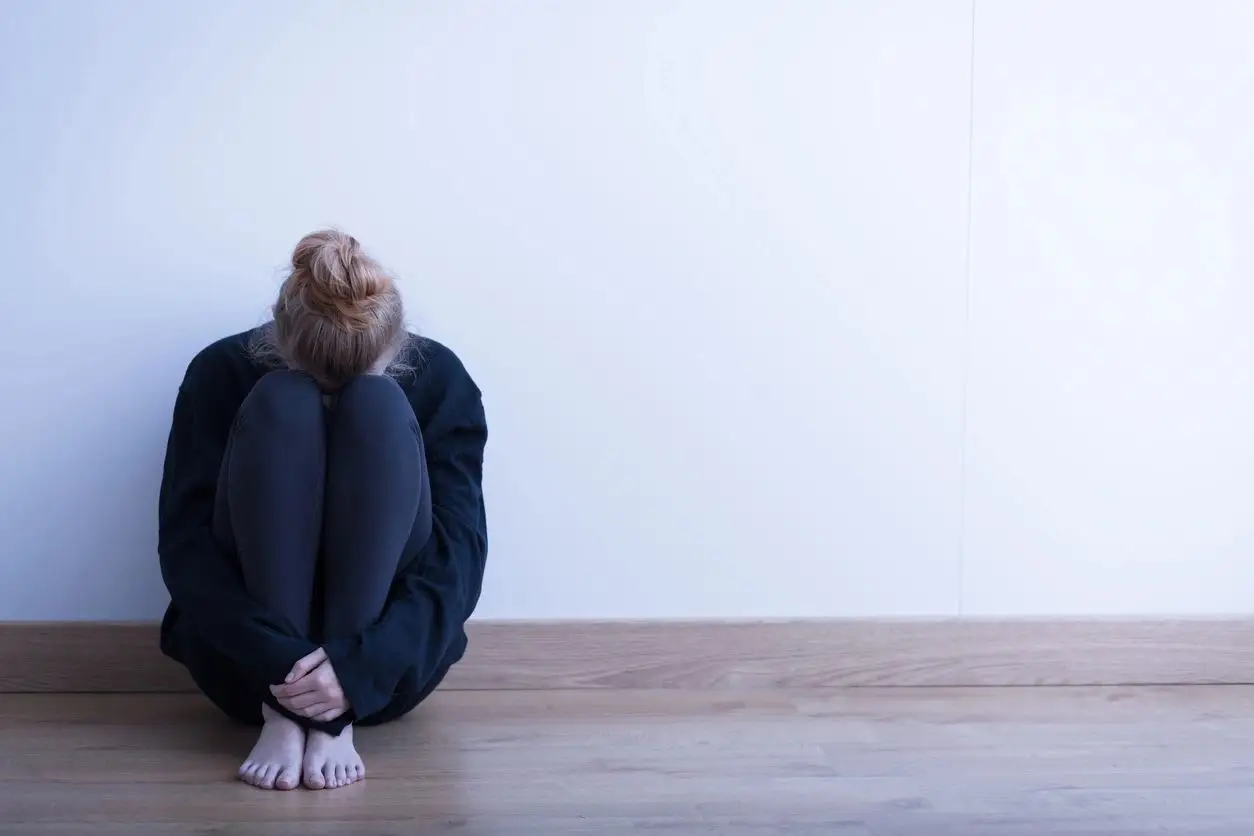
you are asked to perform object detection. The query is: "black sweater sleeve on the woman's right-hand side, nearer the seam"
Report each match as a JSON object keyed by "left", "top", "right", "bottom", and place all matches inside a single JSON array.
[{"left": 326, "top": 363, "right": 488, "bottom": 717}]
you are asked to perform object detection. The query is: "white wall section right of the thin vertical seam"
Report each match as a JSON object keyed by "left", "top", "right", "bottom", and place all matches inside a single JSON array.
[{"left": 963, "top": 0, "right": 1254, "bottom": 613}]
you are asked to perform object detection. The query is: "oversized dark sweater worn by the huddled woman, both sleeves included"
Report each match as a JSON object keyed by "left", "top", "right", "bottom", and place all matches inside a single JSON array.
[{"left": 158, "top": 332, "right": 488, "bottom": 732}]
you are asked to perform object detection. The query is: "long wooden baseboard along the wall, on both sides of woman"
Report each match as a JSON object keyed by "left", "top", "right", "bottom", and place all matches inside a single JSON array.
[{"left": 0, "top": 619, "right": 1254, "bottom": 693}]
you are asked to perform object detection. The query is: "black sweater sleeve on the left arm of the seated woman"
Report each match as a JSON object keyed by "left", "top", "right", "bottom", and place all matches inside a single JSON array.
[{"left": 158, "top": 357, "right": 316, "bottom": 683}]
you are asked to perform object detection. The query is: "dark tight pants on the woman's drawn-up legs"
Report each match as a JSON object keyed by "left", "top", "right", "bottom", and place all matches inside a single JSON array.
[{"left": 213, "top": 371, "right": 431, "bottom": 711}]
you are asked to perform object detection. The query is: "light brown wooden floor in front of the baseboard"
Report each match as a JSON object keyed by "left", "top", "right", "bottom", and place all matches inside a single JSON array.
[{"left": 7, "top": 687, "right": 1254, "bottom": 836}]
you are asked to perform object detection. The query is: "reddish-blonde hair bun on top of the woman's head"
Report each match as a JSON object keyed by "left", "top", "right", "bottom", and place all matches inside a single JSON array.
[{"left": 291, "top": 229, "right": 394, "bottom": 328}]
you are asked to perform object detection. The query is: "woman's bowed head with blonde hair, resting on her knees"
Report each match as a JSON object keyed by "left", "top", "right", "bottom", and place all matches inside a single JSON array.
[{"left": 272, "top": 229, "right": 406, "bottom": 391}]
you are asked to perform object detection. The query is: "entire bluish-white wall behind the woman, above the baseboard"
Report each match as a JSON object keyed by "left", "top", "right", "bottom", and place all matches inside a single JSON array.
[{"left": 0, "top": 0, "right": 1254, "bottom": 619}]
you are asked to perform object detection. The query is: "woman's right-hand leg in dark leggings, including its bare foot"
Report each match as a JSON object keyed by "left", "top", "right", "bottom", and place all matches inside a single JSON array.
[{"left": 303, "top": 375, "right": 431, "bottom": 790}]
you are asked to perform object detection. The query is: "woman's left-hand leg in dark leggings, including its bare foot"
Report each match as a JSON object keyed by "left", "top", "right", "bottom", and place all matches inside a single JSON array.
[{"left": 214, "top": 371, "right": 326, "bottom": 790}]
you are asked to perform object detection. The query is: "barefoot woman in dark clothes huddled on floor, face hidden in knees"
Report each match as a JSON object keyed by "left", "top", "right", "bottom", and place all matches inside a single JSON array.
[{"left": 158, "top": 231, "right": 488, "bottom": 790}]
